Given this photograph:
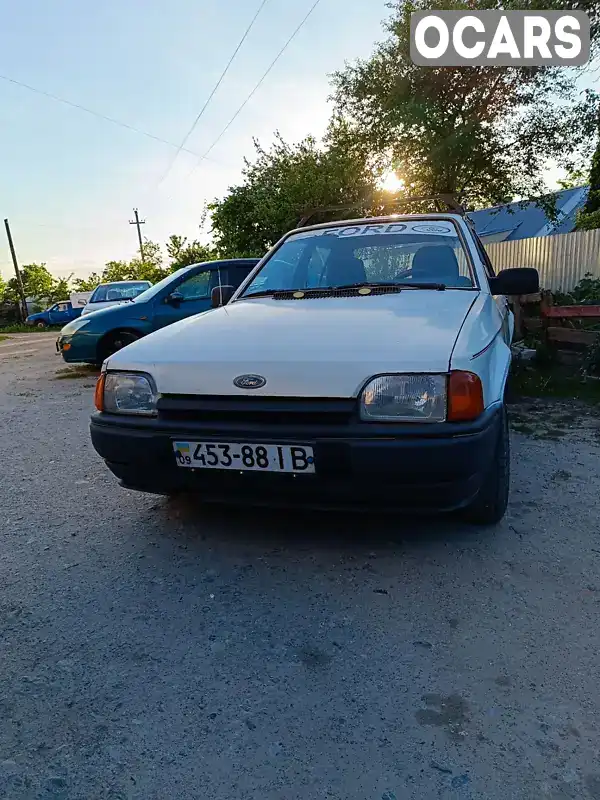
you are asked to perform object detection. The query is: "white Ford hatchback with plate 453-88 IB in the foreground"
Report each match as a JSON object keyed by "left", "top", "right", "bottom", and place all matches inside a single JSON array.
[{"left": 91, "top": 213, "right": 539, "bottom": 523}]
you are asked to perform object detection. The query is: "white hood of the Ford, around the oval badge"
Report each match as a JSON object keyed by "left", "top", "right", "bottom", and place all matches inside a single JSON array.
[{"left": 108, "top": 290, "right": 477, "bottom": 397}]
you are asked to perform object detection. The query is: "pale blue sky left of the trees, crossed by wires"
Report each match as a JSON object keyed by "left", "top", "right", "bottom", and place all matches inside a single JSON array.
[{"left": 0, "top": 0, "right": 389, "bottom": 279}]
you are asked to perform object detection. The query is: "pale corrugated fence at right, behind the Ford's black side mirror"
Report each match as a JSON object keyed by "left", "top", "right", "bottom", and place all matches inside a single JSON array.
[{"left": 485, "top": 228, "right": 600, "bottom": 292}]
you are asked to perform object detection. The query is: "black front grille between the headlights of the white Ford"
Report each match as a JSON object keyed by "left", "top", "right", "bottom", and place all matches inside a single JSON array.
[{"left": 158, "top": 394, "right": 356, "bottom": 426}]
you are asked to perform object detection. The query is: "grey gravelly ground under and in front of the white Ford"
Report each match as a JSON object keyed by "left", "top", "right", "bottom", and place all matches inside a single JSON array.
[{"left": 0, "top": 334, "right": 600, "bottom": 800}]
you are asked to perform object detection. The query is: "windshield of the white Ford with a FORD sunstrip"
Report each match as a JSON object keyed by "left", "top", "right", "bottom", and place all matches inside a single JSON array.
[{"left": 242, "top": 220, "right": 475, "bottom": 296}]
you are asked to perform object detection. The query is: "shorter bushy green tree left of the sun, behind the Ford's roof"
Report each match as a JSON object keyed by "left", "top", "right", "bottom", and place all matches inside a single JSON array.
[{"left": 208, "top": 121, "right": 376, "bottom": 257}]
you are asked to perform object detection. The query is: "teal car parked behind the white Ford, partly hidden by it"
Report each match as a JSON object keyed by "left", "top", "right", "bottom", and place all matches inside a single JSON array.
[{"left": 56, "top": 258, "right": 260, "bottom": 364}]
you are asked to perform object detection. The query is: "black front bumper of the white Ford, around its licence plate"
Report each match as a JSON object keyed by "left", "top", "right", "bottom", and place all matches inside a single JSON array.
[{"left": 90, "top": 404, "right": 502, "bottom": 510}]
